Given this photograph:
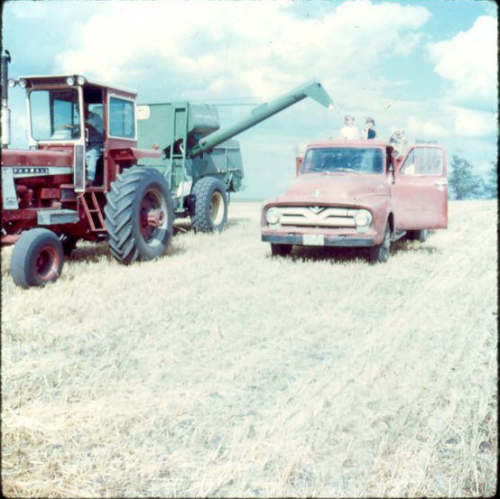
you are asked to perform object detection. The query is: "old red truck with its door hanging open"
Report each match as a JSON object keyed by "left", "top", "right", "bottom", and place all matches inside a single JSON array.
[{"left": 261, "top": 140, "right": 448, "bottom": 262}]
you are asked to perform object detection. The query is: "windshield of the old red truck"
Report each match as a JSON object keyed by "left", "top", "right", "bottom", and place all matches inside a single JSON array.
[{"left": 301, "top": 147, "right": 384, "bottom": 174}]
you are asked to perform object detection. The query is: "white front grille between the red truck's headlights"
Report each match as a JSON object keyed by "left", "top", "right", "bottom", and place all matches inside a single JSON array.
[{"left": 278, "top": 206, "right": 358, "bottom": 228}]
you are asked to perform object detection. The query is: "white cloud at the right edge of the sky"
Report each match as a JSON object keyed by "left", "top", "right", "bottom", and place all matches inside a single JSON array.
[{"left": 427, "top": 16, "right": 498, "bottom": 105}]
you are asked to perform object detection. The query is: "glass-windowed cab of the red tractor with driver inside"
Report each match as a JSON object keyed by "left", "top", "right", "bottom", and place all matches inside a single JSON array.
[{"left": 9, "top": 75, "right": 137, "bottom": 193}]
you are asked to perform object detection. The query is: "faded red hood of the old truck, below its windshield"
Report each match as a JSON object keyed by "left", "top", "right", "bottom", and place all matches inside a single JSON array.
[{"left": 273, "top": 173, "right": 390, "bottom": 205}]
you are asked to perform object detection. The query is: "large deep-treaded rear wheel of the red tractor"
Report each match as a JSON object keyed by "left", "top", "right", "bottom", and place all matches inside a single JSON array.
[{"left": 104, "top": 167, "right": 174, "bottom": 264}]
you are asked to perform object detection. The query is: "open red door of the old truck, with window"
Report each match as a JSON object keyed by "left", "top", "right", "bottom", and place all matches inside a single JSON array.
[{"left": 392, "top": 144, "right": 448, "bottom": 230}]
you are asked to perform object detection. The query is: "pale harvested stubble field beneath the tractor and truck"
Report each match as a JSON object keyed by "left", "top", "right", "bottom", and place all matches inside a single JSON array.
[{"left": 1, "top": 201, "right": 498, "bottom": 497}]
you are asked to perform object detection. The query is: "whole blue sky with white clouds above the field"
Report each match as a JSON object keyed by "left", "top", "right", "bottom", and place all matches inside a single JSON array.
[{"left": 2, "top": 0, "right": 498, "bottom": 198}]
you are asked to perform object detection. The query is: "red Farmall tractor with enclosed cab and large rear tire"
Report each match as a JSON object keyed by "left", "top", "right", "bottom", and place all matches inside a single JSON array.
[{"left": 1, "top": 53, "right": 174, "bottom": 287}]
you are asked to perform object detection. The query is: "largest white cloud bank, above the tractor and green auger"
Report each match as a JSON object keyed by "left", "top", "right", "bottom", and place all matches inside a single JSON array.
[{"left": 54, "top": 0, "right": 429, "bottom": 100}]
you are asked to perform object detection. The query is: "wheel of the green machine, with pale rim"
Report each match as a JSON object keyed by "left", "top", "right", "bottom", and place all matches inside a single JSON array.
[{"left": 191, "top": 177, "right": 228, "bottom": 232}]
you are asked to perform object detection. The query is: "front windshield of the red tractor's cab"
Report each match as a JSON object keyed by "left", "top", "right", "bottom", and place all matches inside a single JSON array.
[{"left": 29, "top": 88, "right": 81, "bottom": 140}]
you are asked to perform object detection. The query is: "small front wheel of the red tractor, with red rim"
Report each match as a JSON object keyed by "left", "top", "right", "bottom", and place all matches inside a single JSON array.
[{"left": 10, "top": 229, "right": 64, "bottom": 288}]
